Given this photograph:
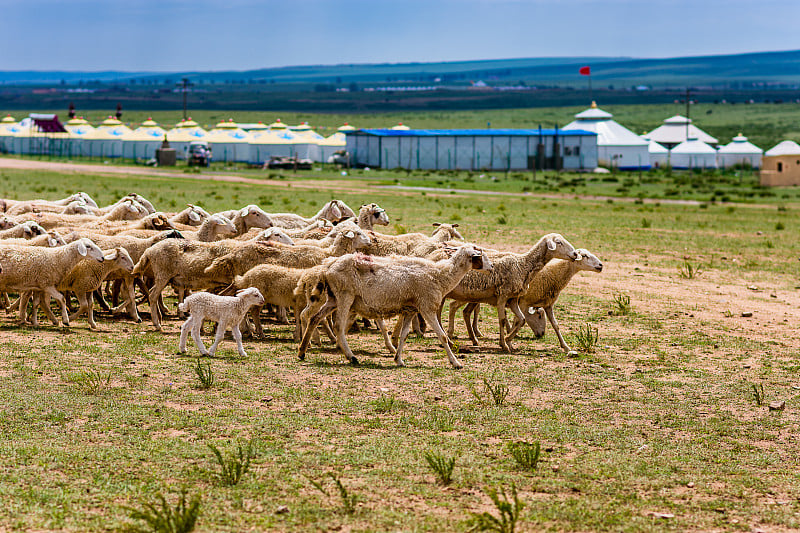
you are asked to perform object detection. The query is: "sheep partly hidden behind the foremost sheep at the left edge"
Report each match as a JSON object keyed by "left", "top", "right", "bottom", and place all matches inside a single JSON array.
[{"left": 34, "top": 247, "right": 133, "bottom": 329}]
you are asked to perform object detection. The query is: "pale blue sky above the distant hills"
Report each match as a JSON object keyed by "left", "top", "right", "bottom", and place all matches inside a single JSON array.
[{"left": 0, "top": 0, "right": 800, "bottom": 71}]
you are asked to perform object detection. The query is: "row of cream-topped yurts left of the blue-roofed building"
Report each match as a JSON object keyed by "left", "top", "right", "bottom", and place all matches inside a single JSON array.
[{"left": 0, "top": 115, "right": 362, "bottom": 163}]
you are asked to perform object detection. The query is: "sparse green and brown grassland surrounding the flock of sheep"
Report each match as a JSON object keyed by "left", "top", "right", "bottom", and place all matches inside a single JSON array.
[{"left": 0, "top": 165, "right": 800, "bottom": 531}]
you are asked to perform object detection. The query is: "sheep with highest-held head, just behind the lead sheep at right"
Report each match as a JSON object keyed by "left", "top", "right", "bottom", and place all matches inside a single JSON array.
[{"left": 437, "top": 233, "right": 578, "bottom": 352}]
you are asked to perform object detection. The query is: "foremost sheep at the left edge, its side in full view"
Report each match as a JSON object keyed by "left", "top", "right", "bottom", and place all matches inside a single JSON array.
[{"left": 0, "top": 238, "right": 103, "bottom": 326}]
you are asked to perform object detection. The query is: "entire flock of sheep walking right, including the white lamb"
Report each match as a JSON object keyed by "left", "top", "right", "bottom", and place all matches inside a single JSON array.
[{"left": 0, "top": 189, "right": 602, "bottom": 368}]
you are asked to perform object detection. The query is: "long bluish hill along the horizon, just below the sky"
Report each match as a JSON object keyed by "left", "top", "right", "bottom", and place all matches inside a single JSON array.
[{"left": 0, "top": 50, "right": 800, "bottom": 88}]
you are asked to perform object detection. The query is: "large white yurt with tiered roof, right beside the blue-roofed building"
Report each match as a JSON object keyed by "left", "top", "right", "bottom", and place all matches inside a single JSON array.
[{"left": 561, "top": 102, "right": 650, "bottom": 170}]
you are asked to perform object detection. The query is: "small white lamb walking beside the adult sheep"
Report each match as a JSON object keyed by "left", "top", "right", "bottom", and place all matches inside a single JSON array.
[{"left": 178, "top": 287, "right": 264, "bottom": 357}]
